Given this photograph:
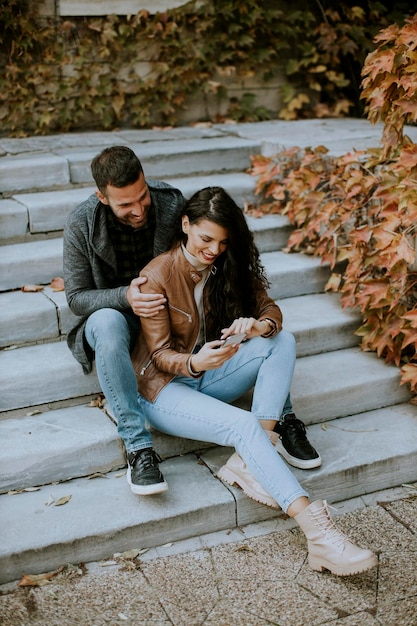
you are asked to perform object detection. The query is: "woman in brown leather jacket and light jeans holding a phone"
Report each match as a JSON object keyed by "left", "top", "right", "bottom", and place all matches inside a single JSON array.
[{"left": 132, "top": 187, "right": 377, "bottom": 575}]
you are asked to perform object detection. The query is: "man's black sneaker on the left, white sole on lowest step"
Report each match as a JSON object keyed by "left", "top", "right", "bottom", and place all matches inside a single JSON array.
[{"left": 127, "top": 448, "right": 168, "bottom": 496}]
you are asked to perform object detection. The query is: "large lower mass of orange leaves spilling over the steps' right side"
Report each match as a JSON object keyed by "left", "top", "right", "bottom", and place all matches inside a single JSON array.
[{"left": 247, "top": 144, "right": 417, "bottom": 391}]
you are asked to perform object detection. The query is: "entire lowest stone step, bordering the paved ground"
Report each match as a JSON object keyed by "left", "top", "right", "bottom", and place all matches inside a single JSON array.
[{"left": 0, "top": 404, "right": 417, "bottom": 583}]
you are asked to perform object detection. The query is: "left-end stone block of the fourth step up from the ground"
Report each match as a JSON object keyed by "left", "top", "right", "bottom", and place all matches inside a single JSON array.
[{"left": 0, "top": 291, "right": 59, "bottom": 347}]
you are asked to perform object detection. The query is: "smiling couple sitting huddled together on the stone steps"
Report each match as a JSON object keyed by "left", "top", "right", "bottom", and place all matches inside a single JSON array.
[{"left": 64, "top": 147, "right": 377, "bottom": 575}]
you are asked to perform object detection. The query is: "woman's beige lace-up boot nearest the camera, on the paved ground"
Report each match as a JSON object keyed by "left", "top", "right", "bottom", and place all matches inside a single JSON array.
[{"left": 294, "top": 500, "right": 378, "bottom": 576}]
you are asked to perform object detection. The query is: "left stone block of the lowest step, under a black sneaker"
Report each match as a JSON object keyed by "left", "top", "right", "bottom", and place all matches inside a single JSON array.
[{"left": 0, "top": 455, "right": 236, "bottom": 582}]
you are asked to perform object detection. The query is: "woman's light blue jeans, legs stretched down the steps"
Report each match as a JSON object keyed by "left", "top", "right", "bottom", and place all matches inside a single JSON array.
[{"left": 139, "top": 331, "right": 308, "bottom": 511}]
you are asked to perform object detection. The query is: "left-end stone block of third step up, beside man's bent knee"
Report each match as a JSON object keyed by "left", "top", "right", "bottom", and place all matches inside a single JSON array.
[{"left": 0, "top": 341, "right": 100, "bottom": 411}]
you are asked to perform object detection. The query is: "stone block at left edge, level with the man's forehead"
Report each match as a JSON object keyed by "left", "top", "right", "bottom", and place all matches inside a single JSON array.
[{"left": 0, "top": 153, "right": 70, "bottom": 192}]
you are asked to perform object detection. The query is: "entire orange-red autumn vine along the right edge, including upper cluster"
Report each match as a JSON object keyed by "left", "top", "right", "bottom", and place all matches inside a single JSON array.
[{"left": 247, "top": 14, "right": 417, "bottom": 392}]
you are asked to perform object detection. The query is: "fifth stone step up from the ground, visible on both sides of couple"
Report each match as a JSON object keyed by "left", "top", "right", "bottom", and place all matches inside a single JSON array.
[{"left": 0, "top": 215, "right": 291, "bottom": 292}]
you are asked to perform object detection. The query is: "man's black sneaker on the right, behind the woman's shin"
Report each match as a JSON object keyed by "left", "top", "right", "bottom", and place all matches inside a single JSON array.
[{"left": 274, "top": 413, "right": 321, "bottom": 469}]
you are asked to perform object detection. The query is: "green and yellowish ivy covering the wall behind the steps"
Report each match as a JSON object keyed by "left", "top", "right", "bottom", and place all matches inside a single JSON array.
[{"left": 0, "top": 0, "right": 410, "bottom": 136}]
